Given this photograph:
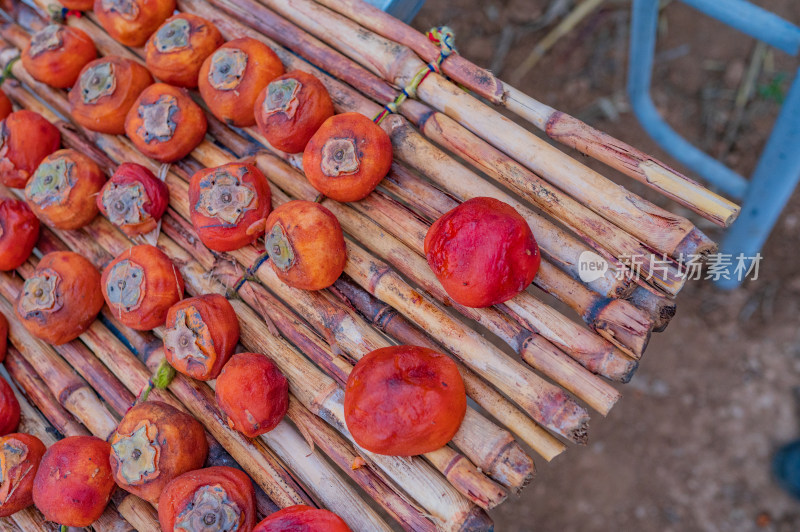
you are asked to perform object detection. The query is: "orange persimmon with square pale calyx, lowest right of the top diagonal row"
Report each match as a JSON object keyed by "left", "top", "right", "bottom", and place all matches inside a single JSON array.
[{"left": 303, "top": 113, "right": 392, "bottom": 202}]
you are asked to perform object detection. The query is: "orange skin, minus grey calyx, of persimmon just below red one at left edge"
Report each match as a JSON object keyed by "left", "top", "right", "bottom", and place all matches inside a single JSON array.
[{"left": 15, "top": 251, "right": 103, "bottom": 345}]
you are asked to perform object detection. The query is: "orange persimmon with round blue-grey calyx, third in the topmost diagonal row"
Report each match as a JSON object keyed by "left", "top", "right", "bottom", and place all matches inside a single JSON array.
[{"left": 197, "top": 37, "right": 283, "bottom": 127}]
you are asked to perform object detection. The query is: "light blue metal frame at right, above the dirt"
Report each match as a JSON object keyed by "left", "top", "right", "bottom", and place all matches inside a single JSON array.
[{"left": 628, "top": 0, "right": 800, "bottom": 288}]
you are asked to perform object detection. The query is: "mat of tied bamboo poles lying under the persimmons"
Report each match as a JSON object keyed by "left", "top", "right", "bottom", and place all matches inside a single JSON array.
[{"left": 0, "top": 0, "right": 738, "bottom": 530}]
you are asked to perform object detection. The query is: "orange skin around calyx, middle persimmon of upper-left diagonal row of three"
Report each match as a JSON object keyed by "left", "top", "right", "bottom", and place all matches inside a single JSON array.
[{"left": 68, "top": 55, "right": 153, "bottom": 135}]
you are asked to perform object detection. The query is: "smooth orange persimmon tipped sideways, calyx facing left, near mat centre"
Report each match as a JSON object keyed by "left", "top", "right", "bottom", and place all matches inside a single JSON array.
[{"left": 265, "top": 200, "right": 347, "bottom": 290}]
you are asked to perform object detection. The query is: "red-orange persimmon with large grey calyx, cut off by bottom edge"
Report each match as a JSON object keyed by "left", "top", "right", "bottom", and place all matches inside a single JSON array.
[{"left": 158, "top": 466, "right": 256, "bottom": 532}]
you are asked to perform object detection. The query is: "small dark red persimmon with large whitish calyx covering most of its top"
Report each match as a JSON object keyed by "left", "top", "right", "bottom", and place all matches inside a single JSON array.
[{"left": 97, "top": 163, "right": 169, "bottom": 236}]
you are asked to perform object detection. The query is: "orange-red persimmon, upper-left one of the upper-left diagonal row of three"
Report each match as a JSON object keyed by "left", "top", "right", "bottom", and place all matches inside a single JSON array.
[{"left": 22, "top": 24, "right": 97, "bottom": 89}]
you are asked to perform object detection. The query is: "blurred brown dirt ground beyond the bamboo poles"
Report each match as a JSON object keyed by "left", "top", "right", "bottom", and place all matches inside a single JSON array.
[{"left": 414, "top": 0, "right": 800, "bottom": 531}]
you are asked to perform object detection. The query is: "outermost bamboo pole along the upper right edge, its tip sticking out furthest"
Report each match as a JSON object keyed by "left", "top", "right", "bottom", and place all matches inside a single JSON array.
[{"left": 316, "top": 0, "right": 740, "bottom": 227}]
